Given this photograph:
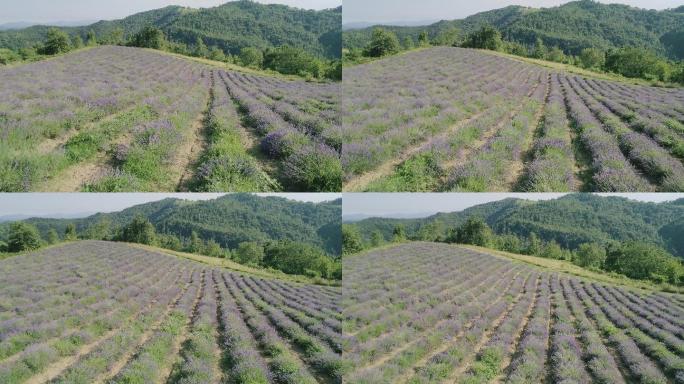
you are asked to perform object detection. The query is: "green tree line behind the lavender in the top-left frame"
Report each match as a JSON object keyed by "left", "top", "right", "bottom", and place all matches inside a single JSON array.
[{"left": 0, "top": 25, "right": 342, "bottom": 81}]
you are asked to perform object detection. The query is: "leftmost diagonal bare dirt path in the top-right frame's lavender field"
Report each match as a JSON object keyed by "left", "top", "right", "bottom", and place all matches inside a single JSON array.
[{"left": 342, "top": 110, "right": 488, "bottom": 192}]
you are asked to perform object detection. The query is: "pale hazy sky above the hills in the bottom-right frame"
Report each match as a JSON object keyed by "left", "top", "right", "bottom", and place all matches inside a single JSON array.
[{"left": 342, "top": 193, "right": 684, "bottom": 217}]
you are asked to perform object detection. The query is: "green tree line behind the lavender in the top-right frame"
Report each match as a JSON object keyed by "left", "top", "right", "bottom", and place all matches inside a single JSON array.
[{"left": 350, "top": 25, "right": 684, "bottom": 84}]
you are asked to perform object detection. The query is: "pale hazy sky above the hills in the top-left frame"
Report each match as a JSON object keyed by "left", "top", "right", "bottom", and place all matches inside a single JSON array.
[{"left": 0, "top": 0, "right": 342, "bottom": 24}]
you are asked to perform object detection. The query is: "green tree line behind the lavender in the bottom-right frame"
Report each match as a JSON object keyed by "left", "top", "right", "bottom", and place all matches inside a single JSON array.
[{"left": 342, "top": 216, "right": 684, "bottom": 286}]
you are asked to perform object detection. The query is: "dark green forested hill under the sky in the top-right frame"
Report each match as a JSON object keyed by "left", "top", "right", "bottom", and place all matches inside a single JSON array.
[{"left": 343, "top": 0, "right": 684, "bottom": 59}]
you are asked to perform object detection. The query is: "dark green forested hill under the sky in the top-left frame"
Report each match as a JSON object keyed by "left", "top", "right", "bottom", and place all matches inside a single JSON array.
[{"left": 0, "top": 0, "right": 342, "bottom": 58}]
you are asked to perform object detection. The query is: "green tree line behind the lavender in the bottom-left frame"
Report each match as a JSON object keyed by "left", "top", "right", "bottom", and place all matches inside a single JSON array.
[{"left": 0, "top": 214, "right": 342, "bottom": 280}]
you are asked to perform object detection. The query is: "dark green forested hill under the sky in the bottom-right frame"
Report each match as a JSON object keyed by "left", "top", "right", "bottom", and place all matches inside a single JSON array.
[{"left": 355, "top": 194, "right": 684, "bottom": 257}]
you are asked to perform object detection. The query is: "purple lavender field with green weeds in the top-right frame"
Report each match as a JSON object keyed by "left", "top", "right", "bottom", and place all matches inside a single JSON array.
[{"left": 341, "top": 47, "right": 684, "bottom": 192}]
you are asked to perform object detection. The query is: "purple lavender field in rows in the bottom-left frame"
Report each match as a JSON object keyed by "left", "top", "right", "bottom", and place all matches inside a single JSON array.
[{"left": 0, "top": 241, "right": 343, "bottom": 384}]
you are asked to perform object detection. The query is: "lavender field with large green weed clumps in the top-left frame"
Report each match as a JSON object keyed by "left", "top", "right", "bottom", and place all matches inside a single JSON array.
[{"left": 0, "top": 46, "right": 342, "bottom": 192}]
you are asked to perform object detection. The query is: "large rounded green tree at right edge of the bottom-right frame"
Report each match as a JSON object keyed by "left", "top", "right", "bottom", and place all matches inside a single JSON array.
[{"left": 605, "top": 241, "right": 684, "bottom": 284}]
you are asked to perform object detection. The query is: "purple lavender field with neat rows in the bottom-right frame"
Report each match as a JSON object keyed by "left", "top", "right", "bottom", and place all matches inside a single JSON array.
[{"left": 342, "top": 243, "right": 684, "bottom": 384}]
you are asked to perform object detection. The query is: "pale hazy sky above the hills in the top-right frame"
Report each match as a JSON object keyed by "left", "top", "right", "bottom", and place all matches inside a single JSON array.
[{"left": 342, "top": 0, "right": 684, "bottom": 23}]
